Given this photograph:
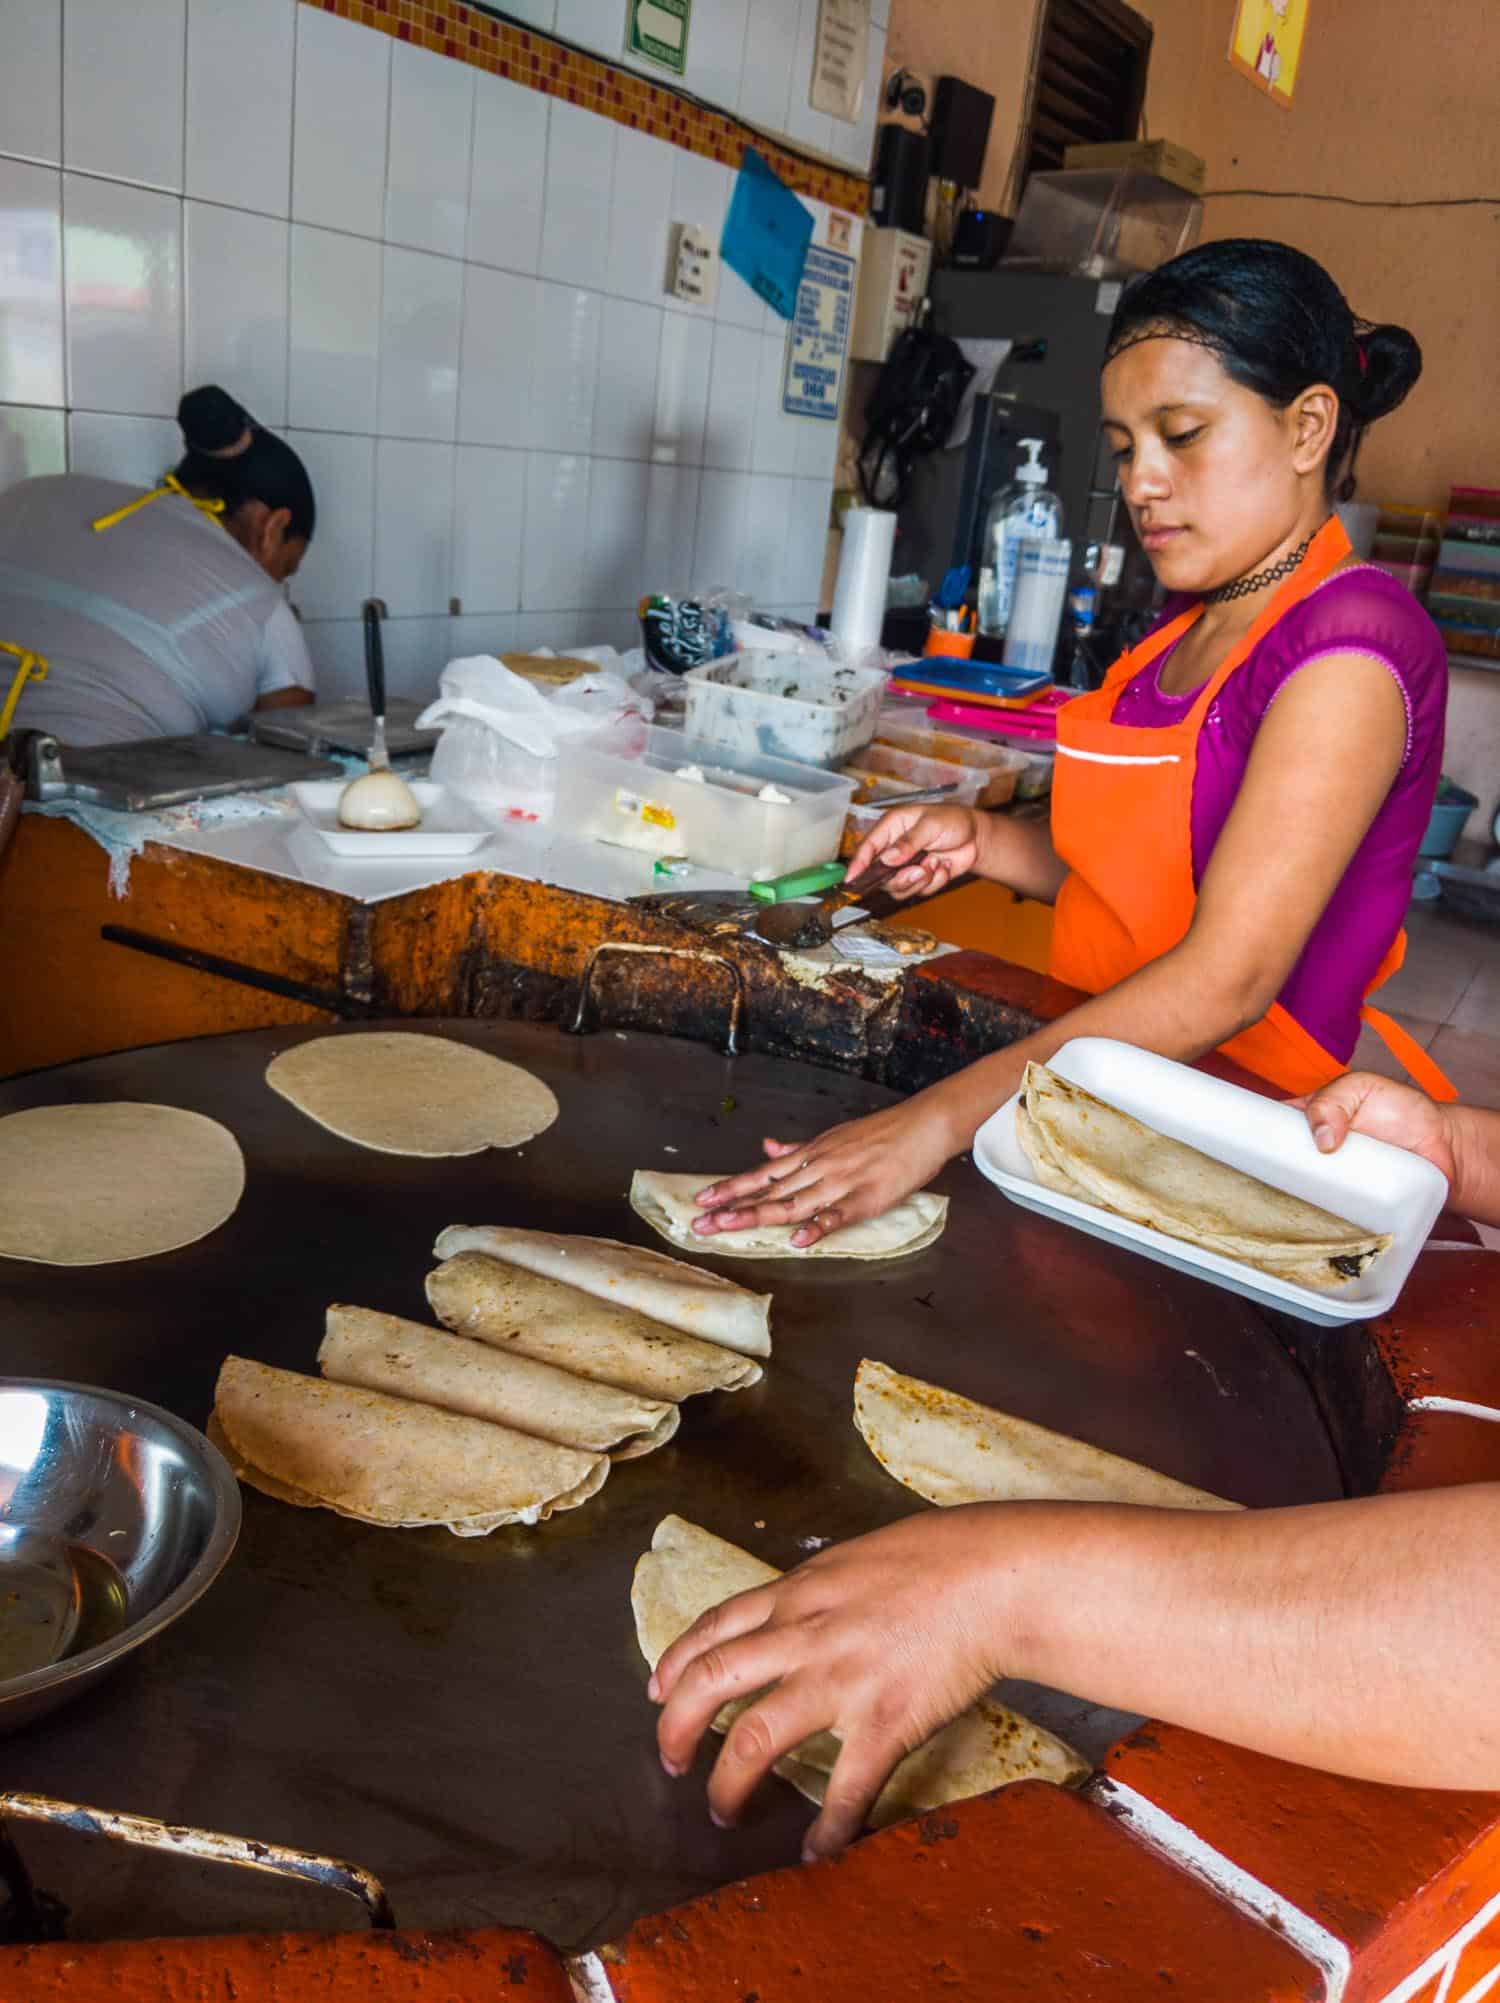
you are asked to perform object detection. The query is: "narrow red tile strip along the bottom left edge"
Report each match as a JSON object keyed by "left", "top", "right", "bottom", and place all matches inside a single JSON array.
[{"left": 0, "top": 1927, "right": 573, "bottom": 2003}]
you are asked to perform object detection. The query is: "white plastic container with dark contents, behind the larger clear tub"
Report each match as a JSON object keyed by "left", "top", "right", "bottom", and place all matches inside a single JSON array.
[{"left": 683, "top": 653, "right": 887, "bottom": 767}]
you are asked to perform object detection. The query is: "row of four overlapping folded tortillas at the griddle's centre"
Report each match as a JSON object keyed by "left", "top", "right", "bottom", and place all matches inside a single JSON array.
[{"left": 210, "top": 1226, "right": 771, "bottom": 1536}]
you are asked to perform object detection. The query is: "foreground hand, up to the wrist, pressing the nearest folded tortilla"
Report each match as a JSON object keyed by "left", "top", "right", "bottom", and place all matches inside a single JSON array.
[{"left": 649, "top": 1502, "right": 1007, "bottom": 1861}]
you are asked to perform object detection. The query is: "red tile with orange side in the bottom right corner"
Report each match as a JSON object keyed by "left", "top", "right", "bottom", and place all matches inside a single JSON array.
[{"left": 1105, "top": 1725, "right": 1500, "bottom": 2003}]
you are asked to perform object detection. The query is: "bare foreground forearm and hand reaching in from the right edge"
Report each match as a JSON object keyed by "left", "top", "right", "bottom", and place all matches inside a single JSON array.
[{"left": 651, "top": 1484, "right": 1500, "bottom": 1859}]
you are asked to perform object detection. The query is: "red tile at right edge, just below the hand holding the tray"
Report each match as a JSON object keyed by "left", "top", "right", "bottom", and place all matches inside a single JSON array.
[{"left": 1370, "top": 1250, "right": 1500, "bottom": 1410}]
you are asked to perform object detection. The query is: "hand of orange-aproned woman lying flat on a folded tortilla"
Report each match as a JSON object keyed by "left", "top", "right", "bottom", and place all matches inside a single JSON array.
[{"left": 693, "top": 1088, "right": 969, "bottom": 1250}]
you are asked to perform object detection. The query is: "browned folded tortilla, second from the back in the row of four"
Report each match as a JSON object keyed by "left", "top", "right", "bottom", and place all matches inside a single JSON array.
[{"left": 427, "top": 1232, "right": 761, "bottom": 1404}]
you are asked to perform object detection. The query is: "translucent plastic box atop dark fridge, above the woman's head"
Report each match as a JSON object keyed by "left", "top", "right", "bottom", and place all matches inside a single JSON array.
[{"left": 1001, "top": 168, "right": 1204, "bottom": 278}]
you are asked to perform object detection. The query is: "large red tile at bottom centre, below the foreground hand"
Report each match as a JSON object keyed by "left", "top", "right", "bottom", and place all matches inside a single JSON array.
[{"left": 605, "top": 1781, "right": 1324, "bottom": 2003}]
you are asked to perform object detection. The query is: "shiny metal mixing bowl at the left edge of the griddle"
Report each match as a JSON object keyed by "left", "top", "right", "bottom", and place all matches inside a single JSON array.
[{"left": 0, "top": 1378, "right": 240, "bottom": 1733}]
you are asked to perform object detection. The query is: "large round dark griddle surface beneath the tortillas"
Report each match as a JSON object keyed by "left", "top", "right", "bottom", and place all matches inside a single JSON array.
[{"left": 0, "top": 1022, "right": 1340, "bottom": 1947}]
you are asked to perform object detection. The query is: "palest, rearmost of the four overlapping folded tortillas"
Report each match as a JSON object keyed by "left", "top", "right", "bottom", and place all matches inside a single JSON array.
[{"left": 433, "top": 1224, "right": 771, "bottom": 1356}]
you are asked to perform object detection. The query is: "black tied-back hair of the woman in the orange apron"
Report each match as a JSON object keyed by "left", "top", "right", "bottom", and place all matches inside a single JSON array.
[{"left": 1105, "top": 236, "right": 1422, "bottom": 501}]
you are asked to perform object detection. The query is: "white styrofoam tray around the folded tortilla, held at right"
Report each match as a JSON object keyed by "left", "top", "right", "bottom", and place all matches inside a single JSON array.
[{"left": 973, "top": 1036, "right": 1448, "bottom": 1328}]
